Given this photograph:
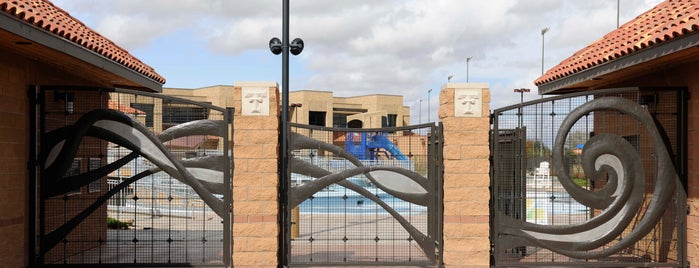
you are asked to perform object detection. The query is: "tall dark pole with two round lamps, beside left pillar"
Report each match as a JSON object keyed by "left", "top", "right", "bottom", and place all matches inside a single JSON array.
[{"left": 269, "top": 0, "right": 303, "bottom": 265}]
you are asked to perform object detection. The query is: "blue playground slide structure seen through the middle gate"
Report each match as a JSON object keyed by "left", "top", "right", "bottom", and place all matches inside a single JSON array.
[{"left": 345, "top": 133, "right": 408, "bottom": 160}]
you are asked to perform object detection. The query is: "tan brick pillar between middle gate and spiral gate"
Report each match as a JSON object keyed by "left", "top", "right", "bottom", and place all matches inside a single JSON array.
[{"left": 439, "top": 83, "right": 490, "bottom": 267}]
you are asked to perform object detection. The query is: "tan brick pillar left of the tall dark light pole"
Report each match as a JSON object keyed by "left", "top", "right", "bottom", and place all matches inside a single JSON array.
[{"left": 232, "top": 82, "right": 280, "bottom": 267}]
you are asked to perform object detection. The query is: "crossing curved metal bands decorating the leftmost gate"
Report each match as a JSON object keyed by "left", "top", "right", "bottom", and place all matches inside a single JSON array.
[{"left": 41, "top": 110, "right": 230, "bottom": 251}]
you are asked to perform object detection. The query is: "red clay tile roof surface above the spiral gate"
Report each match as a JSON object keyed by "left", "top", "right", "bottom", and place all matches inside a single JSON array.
[{"left": 534, "top": 0, "right": 699, "bottom": 86}]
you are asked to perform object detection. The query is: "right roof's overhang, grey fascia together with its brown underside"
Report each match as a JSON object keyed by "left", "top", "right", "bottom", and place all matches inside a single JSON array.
[{"left": 538, "top": 33, "right": 699, "bottom": 95}]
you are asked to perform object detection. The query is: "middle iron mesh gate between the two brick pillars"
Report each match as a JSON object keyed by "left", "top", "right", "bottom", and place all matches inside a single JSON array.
[{"left": 285, "top": 124, "right": 443, "bottom": 266}]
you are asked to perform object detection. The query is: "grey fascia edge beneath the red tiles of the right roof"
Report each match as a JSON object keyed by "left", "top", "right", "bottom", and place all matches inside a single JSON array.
[{"left": 538, "top": 33, "right": 699, "bottom": 95}]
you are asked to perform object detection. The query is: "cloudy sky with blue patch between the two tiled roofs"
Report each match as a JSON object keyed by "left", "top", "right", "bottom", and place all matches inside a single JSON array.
[{"left": 53, "top": 0, "right": 661, "bottom": 123}]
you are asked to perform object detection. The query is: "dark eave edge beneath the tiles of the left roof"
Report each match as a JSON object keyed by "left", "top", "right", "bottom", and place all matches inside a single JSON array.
[{"left": 0, "top": 12, "right": 163, "bottom": 92}]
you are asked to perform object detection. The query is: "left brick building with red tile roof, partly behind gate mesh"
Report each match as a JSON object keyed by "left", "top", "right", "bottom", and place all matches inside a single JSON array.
[{"left": 0, "top": 0, "right": 165, "bottom": 267}]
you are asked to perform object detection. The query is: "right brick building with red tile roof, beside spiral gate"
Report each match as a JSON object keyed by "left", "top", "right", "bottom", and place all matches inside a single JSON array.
[{"left": 535, "top": 0, "right": 699, "bottom": 263}]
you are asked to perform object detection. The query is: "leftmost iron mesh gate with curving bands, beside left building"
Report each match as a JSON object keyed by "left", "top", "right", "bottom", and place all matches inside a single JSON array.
[{"left": 31, "top": 87, "right": 232, "bottom": 266}]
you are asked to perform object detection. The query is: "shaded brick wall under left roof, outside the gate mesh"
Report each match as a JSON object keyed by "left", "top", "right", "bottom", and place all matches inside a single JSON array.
[{"left": 0, "top": 50, "right": 110, "bottom": 267}]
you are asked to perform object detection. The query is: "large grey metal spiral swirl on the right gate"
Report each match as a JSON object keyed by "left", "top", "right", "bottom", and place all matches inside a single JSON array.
[{"left": 499, "top": 97, "right": 681, "bottom": 259}]
